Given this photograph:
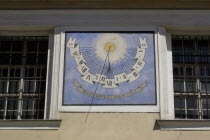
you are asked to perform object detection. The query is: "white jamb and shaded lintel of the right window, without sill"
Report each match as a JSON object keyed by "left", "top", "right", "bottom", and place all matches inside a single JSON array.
[{"left": 158, "top": 26, "right": 210, "bottom": 120}]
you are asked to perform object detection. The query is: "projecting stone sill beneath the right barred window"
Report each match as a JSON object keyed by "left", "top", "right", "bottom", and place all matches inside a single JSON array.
[{"left": 156, "top": 120, "right": 210, "bottom": 131}]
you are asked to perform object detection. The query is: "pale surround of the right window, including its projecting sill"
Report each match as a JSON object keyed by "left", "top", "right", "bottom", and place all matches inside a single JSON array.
[{"left": 156, "top": 26, "right": 210, "bottom": 131}]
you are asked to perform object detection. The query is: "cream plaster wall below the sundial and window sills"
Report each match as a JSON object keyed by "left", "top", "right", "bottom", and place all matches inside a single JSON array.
[{"left": 0, "top": 113, "right": 210, "bottom": 140}]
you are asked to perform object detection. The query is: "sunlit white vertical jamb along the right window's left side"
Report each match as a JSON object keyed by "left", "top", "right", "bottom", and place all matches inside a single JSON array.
[{"left": 158, "top": 27, "right": 174, "bottom": 120}]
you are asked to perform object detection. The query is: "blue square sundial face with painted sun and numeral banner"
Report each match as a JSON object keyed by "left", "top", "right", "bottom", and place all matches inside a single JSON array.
[{"left": 63, "top": 32, "right": 156, "bottom": 105}]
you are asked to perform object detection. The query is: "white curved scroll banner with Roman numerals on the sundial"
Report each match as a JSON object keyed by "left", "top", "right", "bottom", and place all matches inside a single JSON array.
[{"left": 67, "top": 37, "right": 148, "bottom": 88}]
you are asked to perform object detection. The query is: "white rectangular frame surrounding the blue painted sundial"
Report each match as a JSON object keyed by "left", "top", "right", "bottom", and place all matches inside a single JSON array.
[{"left": 54, "top": 26, "right": 160, "bottom": 112}]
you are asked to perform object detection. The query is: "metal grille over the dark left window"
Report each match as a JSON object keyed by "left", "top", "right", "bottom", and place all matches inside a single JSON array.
[{"left": 0, "top": 37, "right": 48, "bottom": 120}]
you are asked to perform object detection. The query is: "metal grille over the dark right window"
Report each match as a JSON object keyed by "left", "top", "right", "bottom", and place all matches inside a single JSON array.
[{"left": 172, "top": 36, "right": 210, "bottom": 119}]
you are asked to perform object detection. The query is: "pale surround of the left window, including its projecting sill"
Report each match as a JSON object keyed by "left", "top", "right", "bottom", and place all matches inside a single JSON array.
[{"left": 0, "top": 30, "right": 61, "bottom": 130}]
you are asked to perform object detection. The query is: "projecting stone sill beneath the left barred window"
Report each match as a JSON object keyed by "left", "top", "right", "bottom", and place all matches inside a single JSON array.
[{"left": 0, "top": 120, "right": 62, "bottom": 130}]
